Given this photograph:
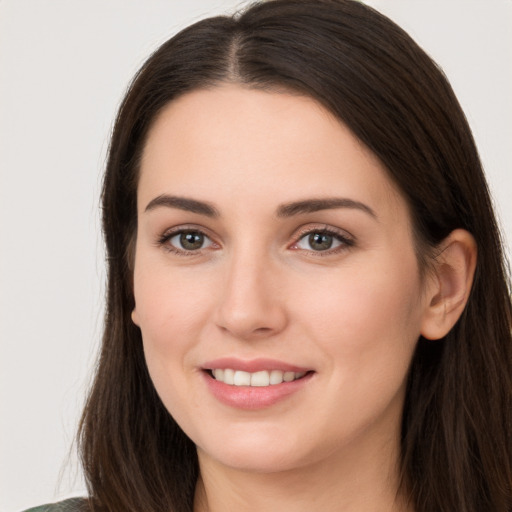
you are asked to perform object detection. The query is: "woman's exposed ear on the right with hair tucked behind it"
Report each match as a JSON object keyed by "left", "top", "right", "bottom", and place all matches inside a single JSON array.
[{"left": 421, "top": 229, "right": 477, "bottom": 340}]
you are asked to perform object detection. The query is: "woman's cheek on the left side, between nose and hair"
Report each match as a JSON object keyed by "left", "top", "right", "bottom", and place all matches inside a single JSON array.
[{"left": 134, "top": 253, "right": 222, "bottom": 410}]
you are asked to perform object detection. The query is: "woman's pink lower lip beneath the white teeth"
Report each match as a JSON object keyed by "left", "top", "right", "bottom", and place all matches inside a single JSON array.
[{"left": 203, "top": 372, "right": 313, "bottom": 410}]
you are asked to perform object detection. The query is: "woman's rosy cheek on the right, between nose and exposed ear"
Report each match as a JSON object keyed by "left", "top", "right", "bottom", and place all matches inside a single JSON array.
[{"left": 294, "top": 252, "right": 422, "bottom": 381}]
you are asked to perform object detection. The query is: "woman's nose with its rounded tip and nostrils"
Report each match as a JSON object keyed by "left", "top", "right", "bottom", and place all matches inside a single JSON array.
[{"left": 215, "top": 248, "right": 288, "bottom": 340}]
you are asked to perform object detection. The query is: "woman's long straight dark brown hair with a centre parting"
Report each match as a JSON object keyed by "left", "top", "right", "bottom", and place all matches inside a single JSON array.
[{"left": 79, "top": 0, "right": 512, "bottom": 512}]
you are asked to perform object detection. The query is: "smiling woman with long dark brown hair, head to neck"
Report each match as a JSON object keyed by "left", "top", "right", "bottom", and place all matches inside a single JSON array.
[{"left": 26, "top": 0, "right": 512, "bottom": 512}]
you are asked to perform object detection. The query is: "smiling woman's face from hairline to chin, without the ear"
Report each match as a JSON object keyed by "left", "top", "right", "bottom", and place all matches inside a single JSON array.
[{"left": 133, "top": 85, "right": 432, "bottom": 471}]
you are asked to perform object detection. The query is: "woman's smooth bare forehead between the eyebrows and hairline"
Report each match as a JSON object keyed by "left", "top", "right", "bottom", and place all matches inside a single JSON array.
[{"left": 139, "top": 85, "right": 404, "bottom": 219}]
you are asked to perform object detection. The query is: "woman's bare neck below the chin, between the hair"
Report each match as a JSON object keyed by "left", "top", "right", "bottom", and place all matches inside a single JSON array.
[{"left": 194, "top": 430, "right": 412, "bottom": 512}]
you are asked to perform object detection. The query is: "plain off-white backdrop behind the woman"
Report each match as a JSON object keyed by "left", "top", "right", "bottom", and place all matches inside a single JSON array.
[{"left": 0, "top": 0, "right": 512, "bottom": 512}]
